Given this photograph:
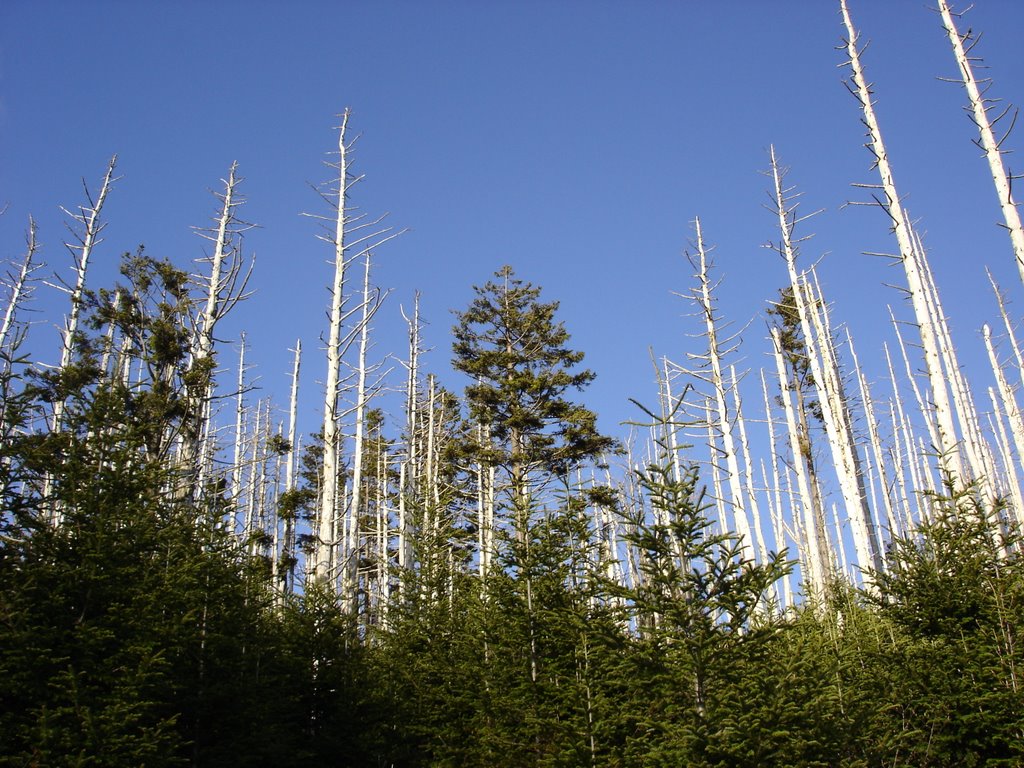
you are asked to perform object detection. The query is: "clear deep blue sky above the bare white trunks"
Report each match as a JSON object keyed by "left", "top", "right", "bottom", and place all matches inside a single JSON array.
[{"left": 0, "top": 0, "right": 1024, "bottom": 454}]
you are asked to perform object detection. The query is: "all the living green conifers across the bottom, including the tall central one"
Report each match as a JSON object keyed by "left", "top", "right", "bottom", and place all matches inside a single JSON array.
[{"left": 0, "top": 256, "right": 1024, "bottom": 767}]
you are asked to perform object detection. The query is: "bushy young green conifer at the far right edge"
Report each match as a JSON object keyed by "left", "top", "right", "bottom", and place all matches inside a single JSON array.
[{"left": 872, "top": 480, "right": 1024, "bottom": 766}]
